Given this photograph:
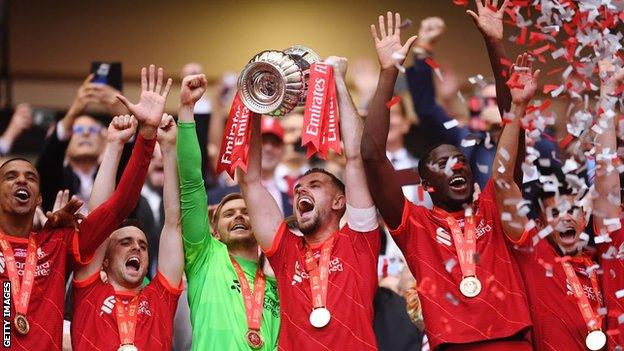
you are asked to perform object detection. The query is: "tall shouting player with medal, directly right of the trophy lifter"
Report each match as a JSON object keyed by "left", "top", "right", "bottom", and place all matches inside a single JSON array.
[{"left": 362, "top": 13, "right": 531, "bottom": 351}]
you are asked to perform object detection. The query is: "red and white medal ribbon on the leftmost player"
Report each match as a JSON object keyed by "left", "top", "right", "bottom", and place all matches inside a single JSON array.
[{"left": 0, "top": 232, "right": 37, "bottom": 316}]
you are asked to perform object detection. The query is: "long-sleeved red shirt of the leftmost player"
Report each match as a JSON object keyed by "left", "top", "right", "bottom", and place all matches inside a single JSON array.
[{"left": 0, "top": 136, "right": 156, "bottom": 351}]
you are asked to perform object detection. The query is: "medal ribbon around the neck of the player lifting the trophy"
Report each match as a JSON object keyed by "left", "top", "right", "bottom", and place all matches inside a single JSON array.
[{"left": 305, "top": 238, "right": 334, "bottom": 308}]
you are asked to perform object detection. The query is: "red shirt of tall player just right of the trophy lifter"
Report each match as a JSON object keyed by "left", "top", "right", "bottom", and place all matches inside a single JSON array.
[{"left": 391, "top": 181, "right": 531, "bottom": 350}]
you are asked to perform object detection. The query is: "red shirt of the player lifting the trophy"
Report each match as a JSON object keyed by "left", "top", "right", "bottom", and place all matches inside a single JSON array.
[{"left": 266, "top": 223, "right": 380, "bottom": 351}]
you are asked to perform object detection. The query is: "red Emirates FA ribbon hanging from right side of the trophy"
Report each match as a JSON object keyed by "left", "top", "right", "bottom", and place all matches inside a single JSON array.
[{"left": 301, "top": 62, "right": 342, "bottom": 159}]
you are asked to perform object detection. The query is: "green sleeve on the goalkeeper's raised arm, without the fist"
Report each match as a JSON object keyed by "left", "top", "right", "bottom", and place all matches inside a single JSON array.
[{"left": 177, "top": 122, "right": 213, "bottom": 264}]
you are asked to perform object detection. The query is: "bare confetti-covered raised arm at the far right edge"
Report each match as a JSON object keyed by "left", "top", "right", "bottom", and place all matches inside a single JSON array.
[{"left": 592, "top": 60, "right": 624, "bottom": 233}]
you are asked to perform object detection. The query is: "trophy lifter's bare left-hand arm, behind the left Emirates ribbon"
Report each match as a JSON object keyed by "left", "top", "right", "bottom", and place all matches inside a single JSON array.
[{"left": 236, "top": 116, "right": 284, "bottom": 251}]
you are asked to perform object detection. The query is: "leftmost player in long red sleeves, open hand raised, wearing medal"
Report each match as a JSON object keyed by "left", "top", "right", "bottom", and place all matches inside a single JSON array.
[{"left": 0, "top": 64, "right": 170, "bottom": 350}]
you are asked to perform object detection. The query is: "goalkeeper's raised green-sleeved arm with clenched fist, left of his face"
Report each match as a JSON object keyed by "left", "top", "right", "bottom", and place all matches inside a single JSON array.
[{"left": 177, "top": 74, "right": 212, "bottom": 245}]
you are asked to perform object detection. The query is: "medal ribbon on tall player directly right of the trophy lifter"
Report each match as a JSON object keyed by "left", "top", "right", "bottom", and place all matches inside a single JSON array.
[{"left": 446, "top": 210, "right": 477, "bottom": 277}]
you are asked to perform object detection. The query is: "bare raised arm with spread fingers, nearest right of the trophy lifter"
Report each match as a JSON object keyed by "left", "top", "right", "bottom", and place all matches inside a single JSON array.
[{"left": 361, "top": 12, "right": 416, "bottom": 229}]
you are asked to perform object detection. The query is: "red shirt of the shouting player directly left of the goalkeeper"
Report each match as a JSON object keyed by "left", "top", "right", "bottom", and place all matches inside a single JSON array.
[{"left": 71, "top": 272, "right": 182, "bottom": 351}]
